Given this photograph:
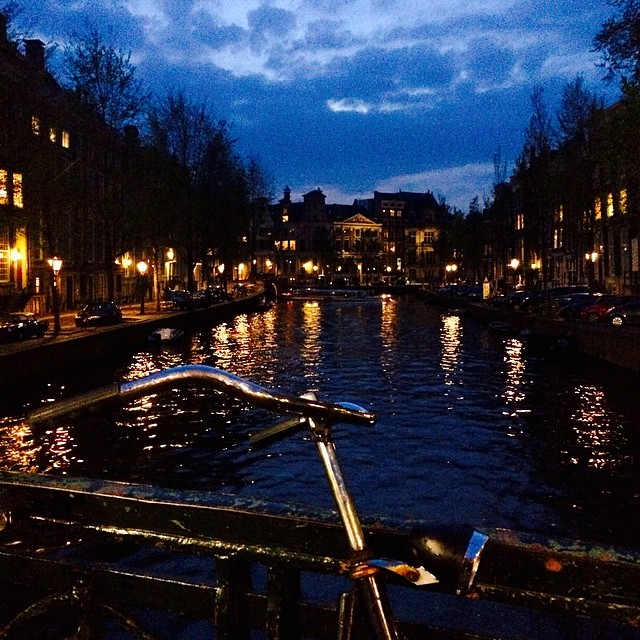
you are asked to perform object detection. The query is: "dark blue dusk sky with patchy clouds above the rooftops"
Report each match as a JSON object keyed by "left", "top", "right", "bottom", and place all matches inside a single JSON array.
[{"left": 21, "top": 0, "right": 617, "bottom": 211}]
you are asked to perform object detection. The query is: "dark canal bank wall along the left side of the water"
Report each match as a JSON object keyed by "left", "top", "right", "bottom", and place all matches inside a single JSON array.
[{"left": 0, "top": 292, "right": 261, "bottom": 387}]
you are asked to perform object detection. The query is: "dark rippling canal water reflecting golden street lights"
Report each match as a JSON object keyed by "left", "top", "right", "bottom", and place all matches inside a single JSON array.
[{"left": 0, "top": 296, "right": 640, "bottom": 546}]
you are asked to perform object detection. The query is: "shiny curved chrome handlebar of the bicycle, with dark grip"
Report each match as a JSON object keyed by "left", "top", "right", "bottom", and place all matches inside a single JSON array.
[{"left": 29, "top": 365, "right": 376, "bottom": 425}]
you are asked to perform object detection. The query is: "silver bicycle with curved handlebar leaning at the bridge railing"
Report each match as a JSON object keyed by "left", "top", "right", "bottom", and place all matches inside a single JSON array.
[{"left": 29, "top": 365, "right": 488, "bottom": 640}]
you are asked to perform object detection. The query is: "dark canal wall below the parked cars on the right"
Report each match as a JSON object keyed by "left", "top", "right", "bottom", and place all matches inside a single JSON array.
[{"left": 415, "top": 290, "right": 640, "bottom": 372}]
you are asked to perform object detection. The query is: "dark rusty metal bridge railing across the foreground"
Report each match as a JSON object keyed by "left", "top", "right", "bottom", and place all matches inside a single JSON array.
[{"left": 0, "top": 472, "right": 640, "bottom": 639}]
